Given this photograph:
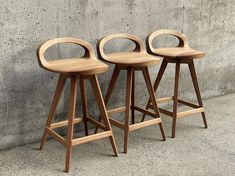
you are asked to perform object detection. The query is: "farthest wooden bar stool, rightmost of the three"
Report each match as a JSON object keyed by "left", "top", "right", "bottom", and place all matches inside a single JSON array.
[{"left": 142, "top": 30, "right": 207, "bottom": 138}]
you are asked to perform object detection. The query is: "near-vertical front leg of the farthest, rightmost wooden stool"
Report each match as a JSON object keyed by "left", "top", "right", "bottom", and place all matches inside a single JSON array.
[{"left": 172, "top": 62, "right": 180, "bottom": 138}]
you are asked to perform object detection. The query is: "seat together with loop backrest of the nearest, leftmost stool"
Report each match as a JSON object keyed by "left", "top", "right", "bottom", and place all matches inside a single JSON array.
[{"left": 38, "top": 38, "right": 108, "bottom": 75}]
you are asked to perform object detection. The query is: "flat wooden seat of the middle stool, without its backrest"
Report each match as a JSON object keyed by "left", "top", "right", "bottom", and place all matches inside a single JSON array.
[{"left": 105, "top": 51, "right": 160, "bottom": 66}]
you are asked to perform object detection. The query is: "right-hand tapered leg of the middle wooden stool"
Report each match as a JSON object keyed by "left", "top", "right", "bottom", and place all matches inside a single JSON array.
[{"left": 142, "top": 67, "right": 166, "bottom": 141}]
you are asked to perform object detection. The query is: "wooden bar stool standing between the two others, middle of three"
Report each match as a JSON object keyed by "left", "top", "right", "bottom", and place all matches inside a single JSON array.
[{"left": 96, "top": 34, "right": 165, "bottom": 153}]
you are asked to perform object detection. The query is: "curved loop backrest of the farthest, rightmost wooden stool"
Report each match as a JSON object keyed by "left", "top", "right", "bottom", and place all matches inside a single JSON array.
[{"left": 146, "top": 30, "right": 189, "bottom": 52}]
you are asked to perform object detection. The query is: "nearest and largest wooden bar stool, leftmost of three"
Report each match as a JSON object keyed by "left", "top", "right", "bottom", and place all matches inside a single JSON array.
[{"left": 37, "top": 38, "right": 118, "bottom": 172}]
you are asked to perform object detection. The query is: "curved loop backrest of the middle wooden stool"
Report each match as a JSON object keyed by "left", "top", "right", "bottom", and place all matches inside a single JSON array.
[{"left": 97, "top": 33, "right": 144, "bottom": 60}]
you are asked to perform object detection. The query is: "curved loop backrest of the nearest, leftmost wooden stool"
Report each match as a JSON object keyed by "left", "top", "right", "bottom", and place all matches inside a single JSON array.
[{"left": 37, "top": 38, "right": 96, "bottom": 68}]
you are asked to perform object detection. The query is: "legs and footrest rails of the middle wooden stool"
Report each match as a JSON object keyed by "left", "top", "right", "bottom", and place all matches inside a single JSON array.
[{"left": 95, "top": 65, "right": 166, "bottom": 153}]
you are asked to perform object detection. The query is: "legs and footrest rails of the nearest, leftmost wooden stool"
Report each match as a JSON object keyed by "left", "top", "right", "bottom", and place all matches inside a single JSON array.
[{"left": 40, "top": 74, "right": 118, "bottom": 172}]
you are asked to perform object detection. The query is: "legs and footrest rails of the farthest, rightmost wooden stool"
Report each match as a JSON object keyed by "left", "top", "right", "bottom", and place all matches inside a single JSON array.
[{"left": 142, "top": 58, "right": 207, "bottom": 138}]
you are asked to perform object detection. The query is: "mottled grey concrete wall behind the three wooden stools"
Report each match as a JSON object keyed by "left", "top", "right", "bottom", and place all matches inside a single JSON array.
[{"left": 0, "top": 0, "right": 235, "bottom": 150}]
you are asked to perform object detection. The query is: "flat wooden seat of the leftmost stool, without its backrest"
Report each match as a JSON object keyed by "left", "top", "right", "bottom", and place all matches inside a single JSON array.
[{"left": 47, "top": 58, "right": 108, "bottom": 75}]
